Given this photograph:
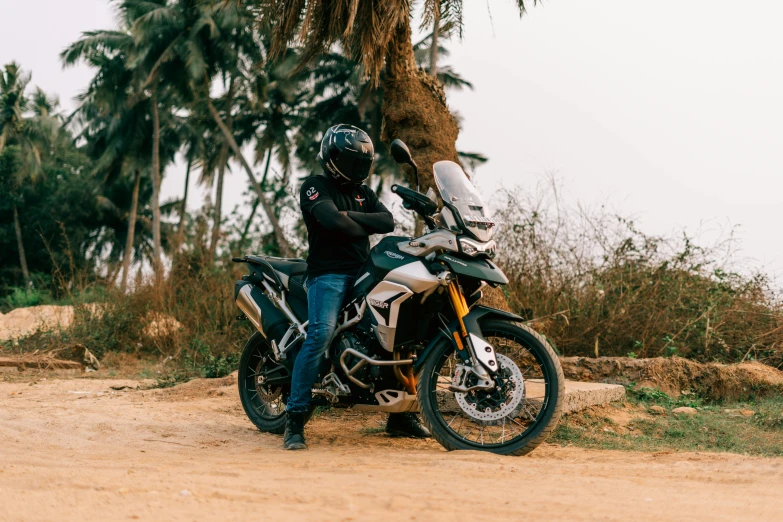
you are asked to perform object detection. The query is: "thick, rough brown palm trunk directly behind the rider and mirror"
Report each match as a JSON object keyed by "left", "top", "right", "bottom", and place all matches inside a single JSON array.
[{"left": 382, "top": 10, "right": 459, "bottom": 192}]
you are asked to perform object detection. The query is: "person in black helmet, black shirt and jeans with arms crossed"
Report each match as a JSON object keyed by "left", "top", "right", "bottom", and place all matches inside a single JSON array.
[{"left": 283, "top": 124, "right": 429, "bottom": 450}]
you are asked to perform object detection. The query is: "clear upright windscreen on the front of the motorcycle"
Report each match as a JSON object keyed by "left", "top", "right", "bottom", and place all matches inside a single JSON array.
[{"left": 433, "top": 161, "right": 495, "bottom": 241}]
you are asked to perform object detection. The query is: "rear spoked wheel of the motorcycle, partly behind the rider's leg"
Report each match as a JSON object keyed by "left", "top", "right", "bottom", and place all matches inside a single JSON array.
[{"left": 238, "top": 333, "right": 314, "bottom": 433}]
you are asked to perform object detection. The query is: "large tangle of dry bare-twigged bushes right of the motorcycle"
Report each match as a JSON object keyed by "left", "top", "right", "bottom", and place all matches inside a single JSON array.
[{"left": 499, "top": 184, "right": 783, "bottom": 368}]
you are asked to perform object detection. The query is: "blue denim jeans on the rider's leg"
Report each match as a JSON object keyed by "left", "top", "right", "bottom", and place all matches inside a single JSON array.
[{"left": 286, "top": 274, "right": 356, "bottom": 413}]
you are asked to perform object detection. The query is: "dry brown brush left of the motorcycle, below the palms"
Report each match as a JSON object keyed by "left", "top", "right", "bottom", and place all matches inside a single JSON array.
[{"left": 6, "top": 248, "right": 251, "bottom": 383}]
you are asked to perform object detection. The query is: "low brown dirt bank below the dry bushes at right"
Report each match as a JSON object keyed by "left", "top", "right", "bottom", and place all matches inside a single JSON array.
[{"left": 560, "top": 357, "right": 783, "bottom": 400}]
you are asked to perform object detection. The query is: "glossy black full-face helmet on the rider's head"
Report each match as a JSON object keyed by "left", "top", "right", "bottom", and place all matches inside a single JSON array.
[{"left": 318, "top": 123, "right": 375, "bottom": 185}]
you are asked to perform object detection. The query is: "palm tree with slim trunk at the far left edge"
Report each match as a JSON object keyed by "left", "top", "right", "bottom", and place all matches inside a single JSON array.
[{"left": 0, "top": 62, "right": 61, "bottom": 286}]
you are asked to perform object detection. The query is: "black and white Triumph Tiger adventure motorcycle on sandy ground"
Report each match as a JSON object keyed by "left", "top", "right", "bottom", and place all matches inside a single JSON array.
[{"left": 233, "top": 140, "right": 565, "bottom": 455}]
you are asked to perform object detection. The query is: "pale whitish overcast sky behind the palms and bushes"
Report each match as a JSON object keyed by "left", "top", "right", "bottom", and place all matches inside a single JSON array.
[{"left": 0, "top": 0, "right": 783, "bottom": 278}]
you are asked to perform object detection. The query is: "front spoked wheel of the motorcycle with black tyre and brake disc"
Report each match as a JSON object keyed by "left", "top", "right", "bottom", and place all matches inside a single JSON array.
[{"left": 418, "top": 320, "right": 565, "bottom": 455}]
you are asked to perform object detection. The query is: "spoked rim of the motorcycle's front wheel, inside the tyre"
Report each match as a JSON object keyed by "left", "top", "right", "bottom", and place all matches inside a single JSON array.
[{"left": 430, "top": 330, "right": 553, "bottom": 448}]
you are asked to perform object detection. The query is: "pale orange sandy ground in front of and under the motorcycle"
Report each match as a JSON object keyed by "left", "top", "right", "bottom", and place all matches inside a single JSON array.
[{"left": 0, "top": 370, "right": 783, "bottom": 522}]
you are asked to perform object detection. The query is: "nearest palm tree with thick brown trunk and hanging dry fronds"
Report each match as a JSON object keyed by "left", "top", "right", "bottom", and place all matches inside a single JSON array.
[{"left": 259, "top": 0, "right": 535, "bottom": 188}]
